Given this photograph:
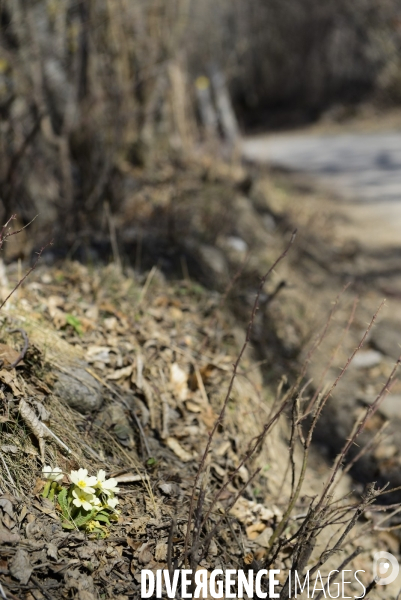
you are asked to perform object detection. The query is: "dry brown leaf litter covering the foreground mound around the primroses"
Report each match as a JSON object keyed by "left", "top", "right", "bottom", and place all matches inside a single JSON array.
[{"left": 0, "top": 263, "right": 294, "bottom": 600}]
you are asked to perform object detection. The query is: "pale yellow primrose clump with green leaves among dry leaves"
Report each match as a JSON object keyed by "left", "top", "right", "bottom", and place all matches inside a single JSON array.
[{"left": 42, "top": 466, "right": 119, "bottom": 534}]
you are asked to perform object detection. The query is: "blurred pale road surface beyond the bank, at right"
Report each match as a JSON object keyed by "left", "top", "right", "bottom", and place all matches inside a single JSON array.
[{"left": 243, "top": 132, "right": 401, "bottom": 248}]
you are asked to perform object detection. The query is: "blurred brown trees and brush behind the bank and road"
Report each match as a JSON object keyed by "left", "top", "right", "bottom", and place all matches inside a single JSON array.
[{"left": 0, "top": 0, "right": 401, "bottom": 247}]
